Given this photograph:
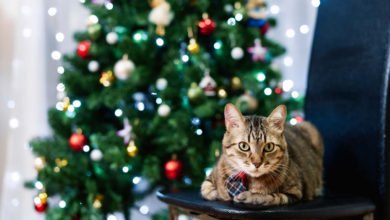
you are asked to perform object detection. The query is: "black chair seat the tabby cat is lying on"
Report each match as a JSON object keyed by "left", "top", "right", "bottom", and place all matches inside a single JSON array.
[{"left": 157, "top": 190, "right": 375, "bottom": 219}]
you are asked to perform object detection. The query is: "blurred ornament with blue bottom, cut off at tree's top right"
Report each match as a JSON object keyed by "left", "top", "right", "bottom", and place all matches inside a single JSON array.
[{"left": 246, "top": 0, "right": 267, "bottom": 28}]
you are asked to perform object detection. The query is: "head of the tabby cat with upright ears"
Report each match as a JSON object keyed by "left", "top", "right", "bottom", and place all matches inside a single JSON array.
[{"left": 222, "top": 104, "right": 287, "bottom": 177}]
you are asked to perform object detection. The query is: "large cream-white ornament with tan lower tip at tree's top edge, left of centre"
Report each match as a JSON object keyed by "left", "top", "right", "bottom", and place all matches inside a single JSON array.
[{"left": 149, "top": 0, "right": 173, "bottom": 36}]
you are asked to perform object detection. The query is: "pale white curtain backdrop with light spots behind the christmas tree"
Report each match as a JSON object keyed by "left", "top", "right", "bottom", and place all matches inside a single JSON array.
[{"left": 0, "top": 0, "right": 320, "bottom": 220}]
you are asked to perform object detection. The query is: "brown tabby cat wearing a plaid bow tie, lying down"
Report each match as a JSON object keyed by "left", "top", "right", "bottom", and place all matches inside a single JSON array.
[{"left": 201, "top": 103, "right": 324, "bottom": 206}]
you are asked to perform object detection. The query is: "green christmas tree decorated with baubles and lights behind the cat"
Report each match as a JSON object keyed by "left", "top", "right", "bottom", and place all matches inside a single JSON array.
[{"left": 27, "top": 0, "right": 302, "bottom": 219}]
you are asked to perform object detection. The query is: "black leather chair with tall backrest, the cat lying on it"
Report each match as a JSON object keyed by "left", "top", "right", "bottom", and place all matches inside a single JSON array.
[{"left": 157, "top": 0, "right": 390, "bottom": 217}]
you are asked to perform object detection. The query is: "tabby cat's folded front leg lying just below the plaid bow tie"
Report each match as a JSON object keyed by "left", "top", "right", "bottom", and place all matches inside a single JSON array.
[{"left": 234, "top": 191, "right": 289, "bottom": 206}]
